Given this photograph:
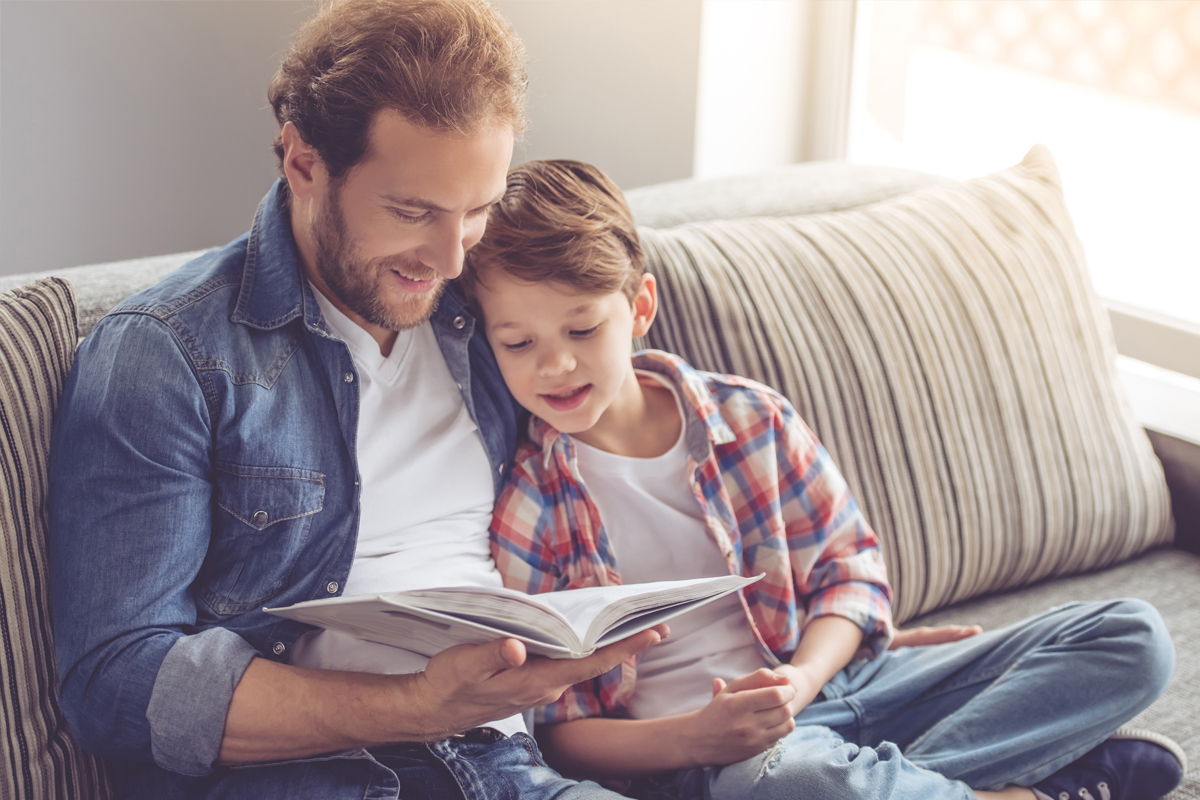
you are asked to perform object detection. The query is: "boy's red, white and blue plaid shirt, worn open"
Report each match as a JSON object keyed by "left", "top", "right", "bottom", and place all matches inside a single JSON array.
[{"left": 491, "top": 350, "right": 892, "bottom": 722}]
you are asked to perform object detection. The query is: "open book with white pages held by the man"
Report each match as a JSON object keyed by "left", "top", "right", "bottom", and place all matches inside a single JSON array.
[{"left": 263, "top": 575, "right": 762, "bottom": 658}]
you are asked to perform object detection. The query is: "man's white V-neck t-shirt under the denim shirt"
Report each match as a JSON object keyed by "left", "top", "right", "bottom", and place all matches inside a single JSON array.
[{"left": 292, "top": 287, "right": 526, "bottom": 735}]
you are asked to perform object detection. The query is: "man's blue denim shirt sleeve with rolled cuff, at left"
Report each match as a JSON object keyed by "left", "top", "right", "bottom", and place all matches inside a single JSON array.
[{"left": 49, "top": 313, "right": 247, "bottom": 774}]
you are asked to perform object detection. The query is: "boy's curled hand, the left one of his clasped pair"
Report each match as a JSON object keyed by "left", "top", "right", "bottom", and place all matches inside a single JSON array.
[{"left": 685, "top": 669, "right": 796, "bottom": 765}]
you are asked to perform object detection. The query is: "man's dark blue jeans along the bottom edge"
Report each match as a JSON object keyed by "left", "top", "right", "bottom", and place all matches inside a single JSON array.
[{"left": 113, "top": 733, "right": 622, "bottom": 800}]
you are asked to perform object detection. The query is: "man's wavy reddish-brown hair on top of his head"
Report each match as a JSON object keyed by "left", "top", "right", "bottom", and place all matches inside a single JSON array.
[{"left": 266, "top": 0, "right": 527, "bottom": 179}]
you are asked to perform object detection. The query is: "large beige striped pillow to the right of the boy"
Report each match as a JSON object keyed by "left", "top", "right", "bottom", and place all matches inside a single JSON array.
[{"left": 641, "top": 146, "right": 1172, "bottom": 622}]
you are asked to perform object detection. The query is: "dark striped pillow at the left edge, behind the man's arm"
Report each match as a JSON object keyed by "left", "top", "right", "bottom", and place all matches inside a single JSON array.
[{"left": 0, "top": 278, "right": 112, "bottom": 800}]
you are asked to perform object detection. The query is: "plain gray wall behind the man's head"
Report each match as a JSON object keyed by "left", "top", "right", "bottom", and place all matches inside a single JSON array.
[{"left": 0, "top": 0, "right": 701, "bottom": 275}]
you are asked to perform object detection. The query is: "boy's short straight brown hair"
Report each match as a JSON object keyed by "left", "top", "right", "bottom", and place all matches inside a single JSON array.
[{"left": 458, "top": 158, "right": 643, "bottom": 311}]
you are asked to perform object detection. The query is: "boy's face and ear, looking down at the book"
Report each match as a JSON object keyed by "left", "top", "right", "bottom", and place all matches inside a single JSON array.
[{"left": 478, "top": 270, "right": 655, "bottom": 441}]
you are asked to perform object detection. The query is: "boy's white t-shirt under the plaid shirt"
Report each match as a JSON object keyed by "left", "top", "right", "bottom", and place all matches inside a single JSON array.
[{"left": 575, "top": 371, "right": 767, "bottom": 720}]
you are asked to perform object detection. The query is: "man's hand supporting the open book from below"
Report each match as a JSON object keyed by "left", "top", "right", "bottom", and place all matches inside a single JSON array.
[{"left": 416, "top": 625, "right": 668, "bottom": 740}]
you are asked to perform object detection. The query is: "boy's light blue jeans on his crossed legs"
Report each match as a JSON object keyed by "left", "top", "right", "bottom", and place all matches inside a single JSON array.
[{"left": 632, "top": 600, "right": 1175, "bottom": 800}]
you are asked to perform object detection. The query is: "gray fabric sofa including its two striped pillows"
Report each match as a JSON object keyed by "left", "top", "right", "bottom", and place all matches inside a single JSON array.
[{"left": 0, "top": 148, "right": 1200, "bottom": 800}]
